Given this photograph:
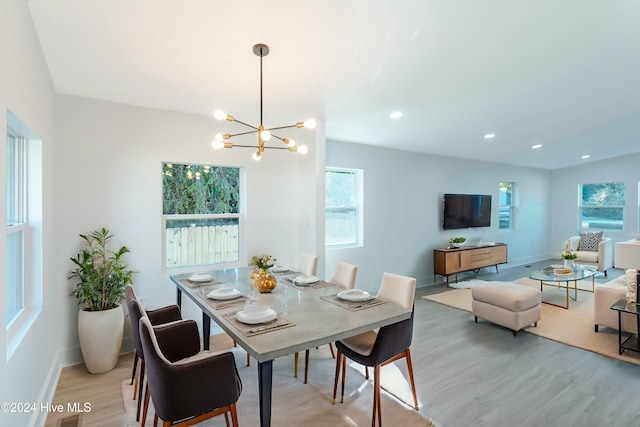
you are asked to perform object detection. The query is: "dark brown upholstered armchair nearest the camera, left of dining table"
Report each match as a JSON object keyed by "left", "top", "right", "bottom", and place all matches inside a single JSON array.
[{"left": 140, "top": 317, "right": 242, "bottom": 427}]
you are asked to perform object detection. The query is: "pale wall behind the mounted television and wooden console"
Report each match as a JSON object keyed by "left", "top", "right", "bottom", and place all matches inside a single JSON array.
[{"left": 326, "top": 141, "right": 551, "bottom": 291}]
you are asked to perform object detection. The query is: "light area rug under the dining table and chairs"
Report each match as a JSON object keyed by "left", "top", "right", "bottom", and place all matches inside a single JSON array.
[{"left": 122, "top": 346, "right": 437, "bottom": 427}]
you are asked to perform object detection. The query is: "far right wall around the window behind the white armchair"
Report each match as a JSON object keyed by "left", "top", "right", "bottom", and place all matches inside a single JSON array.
[{"left": 551, "top": 153, "right": 640, "bottom": 257}]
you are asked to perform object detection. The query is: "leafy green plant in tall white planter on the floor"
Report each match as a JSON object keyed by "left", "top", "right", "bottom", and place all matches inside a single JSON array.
[{"left": 69, "top": 227, "right": 134, "bottom": 374}]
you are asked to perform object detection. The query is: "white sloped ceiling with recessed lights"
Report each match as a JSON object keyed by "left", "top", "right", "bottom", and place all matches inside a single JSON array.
[{"left": 29, "top": 0, "right": 640, "bottom": 169}]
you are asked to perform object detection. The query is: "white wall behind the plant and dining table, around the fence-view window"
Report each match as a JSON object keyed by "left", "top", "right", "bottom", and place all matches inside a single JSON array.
[{"left": 54, "top": 96, "right": 324, "bottom": 352}]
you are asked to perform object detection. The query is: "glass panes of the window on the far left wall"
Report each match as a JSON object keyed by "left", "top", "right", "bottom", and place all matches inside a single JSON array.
[{"left": 6, "top": 132, "right": 27, "bottom": 325}]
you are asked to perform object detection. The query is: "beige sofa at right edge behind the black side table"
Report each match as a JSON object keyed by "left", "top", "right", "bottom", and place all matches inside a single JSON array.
[{"left": 593, "top": 269, "right": 638, "bottom": 333}]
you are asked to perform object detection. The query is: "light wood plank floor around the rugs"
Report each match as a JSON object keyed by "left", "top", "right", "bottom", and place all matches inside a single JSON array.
[{"left": 46, "top": 261, "right": 640, "bottom": 427}]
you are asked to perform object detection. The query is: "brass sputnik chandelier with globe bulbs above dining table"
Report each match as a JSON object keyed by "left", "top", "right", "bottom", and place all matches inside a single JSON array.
[{"left": 211, "top": 44, "right": 316, "bottom": 160}]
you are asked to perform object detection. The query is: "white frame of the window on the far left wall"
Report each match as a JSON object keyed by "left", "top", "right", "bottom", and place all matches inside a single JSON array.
[{"left": 2, "top": 110, "right": 44, "bottom": 360}]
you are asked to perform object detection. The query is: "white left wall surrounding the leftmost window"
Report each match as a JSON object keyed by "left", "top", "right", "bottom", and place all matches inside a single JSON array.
[{"left": 0, "top": 0, "right": 57, "bottom": 426}]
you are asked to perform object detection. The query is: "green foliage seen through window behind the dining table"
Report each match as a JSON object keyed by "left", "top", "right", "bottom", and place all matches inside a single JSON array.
[{"left": 162, "top": 163, "right": 240, "bottom": 215}]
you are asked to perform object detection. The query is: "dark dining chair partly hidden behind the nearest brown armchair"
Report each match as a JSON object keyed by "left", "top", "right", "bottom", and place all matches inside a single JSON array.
[{"left": 124, "top": 285, "right": 182, "bottom": 421}]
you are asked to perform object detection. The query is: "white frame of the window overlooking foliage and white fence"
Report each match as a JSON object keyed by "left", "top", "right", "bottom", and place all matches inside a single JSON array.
[{"left": 161, "top": 162, "right": 246, "bottom": 274}]
